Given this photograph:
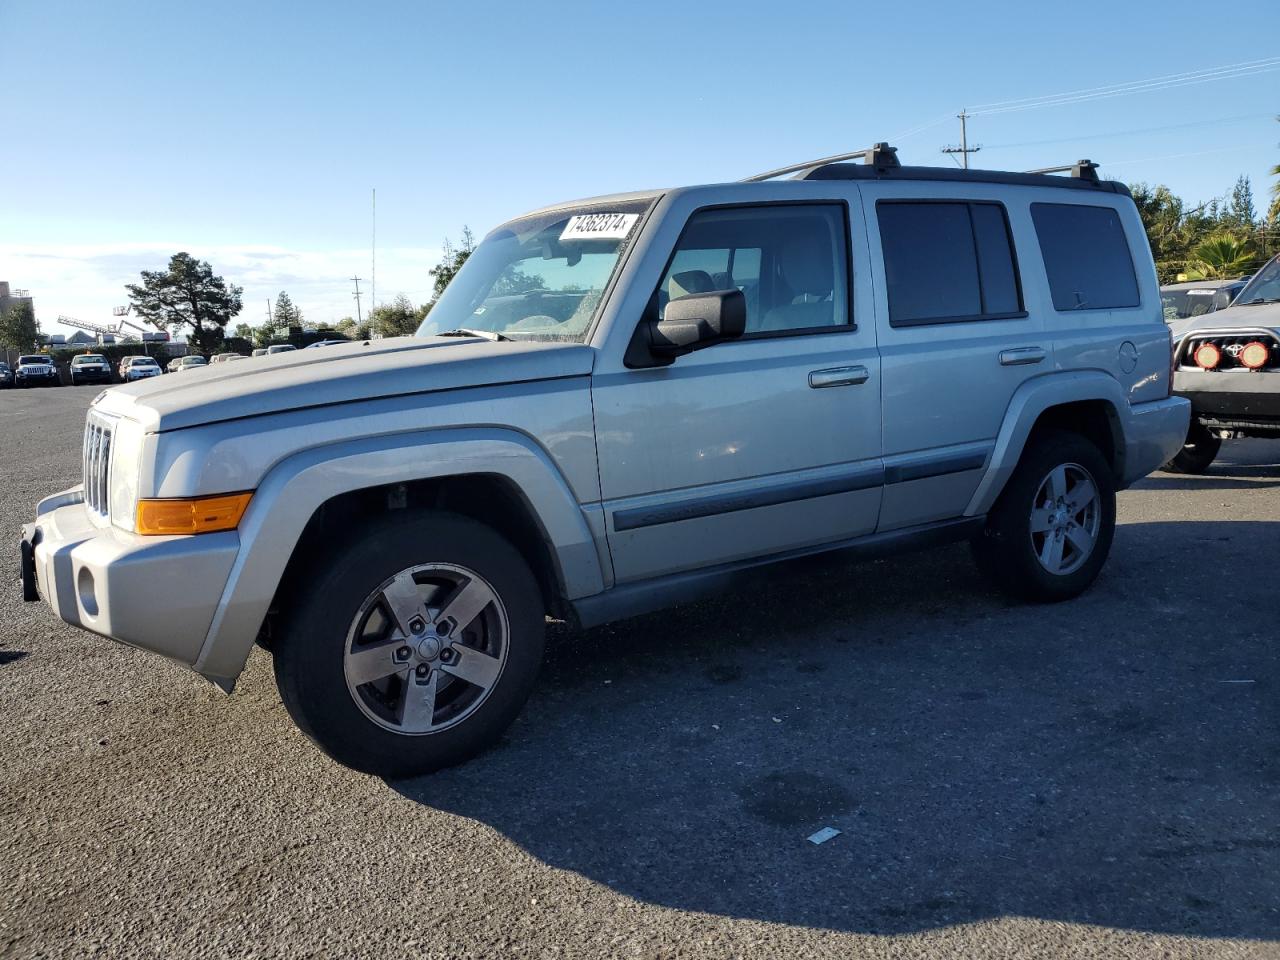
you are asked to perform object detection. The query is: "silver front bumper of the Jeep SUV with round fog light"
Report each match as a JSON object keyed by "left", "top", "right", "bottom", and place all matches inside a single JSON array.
[{"left": 22, "top": 486, "right": 239, "bottom": 667}]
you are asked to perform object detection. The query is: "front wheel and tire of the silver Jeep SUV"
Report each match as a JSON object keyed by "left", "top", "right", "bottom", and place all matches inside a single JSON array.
[{"left": 273, "top": 512, "right": 545, "bottom": 777}]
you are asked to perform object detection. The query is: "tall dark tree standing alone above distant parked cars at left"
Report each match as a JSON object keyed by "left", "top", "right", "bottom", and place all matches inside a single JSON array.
[{"left": 124, "top": 253, "right": 243, "bottom": 355}]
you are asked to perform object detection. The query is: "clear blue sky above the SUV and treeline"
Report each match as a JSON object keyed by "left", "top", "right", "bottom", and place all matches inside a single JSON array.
[{"left": 0, "top": 0, "right": 1280, "bottom": 329}]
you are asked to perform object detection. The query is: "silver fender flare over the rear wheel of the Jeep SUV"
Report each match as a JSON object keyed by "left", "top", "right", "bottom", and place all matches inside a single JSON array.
[{"left": 965, "top": 370, "right": 1135, "bottom": 517}]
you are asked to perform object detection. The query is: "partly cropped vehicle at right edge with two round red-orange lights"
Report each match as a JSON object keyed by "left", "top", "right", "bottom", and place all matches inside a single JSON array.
[{"left": 1166, "top": 255, "right": 1280, "bottom": 474}]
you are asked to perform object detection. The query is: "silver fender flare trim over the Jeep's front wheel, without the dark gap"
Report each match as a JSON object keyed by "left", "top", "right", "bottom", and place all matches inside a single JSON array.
[{"left": 195, "top": 428, "right": 605, "bottom": 690}]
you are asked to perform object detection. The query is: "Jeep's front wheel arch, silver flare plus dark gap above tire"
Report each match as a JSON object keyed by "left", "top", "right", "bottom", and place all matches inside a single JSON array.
[{"left": 195, "top": 429, "right": 605, "bottom": 690}]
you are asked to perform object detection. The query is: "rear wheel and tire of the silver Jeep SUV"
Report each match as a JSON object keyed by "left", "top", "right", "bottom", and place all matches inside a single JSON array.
[{"left": 973, "top": 430, "right": 1116, "bottom": 603}]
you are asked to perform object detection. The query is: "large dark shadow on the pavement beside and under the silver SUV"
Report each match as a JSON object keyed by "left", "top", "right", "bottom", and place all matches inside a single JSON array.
[{"left": 392, "top": 522, "right": 1280, "bottom": 938}]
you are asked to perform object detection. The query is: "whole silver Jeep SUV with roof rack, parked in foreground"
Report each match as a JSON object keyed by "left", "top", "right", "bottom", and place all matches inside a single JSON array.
[{"left": 23, "top": 145, "right": 1189, "bottom": 776}]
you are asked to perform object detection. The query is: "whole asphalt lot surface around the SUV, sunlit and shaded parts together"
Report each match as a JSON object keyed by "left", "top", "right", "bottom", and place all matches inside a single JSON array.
[{"left": 0, "top": 387, "right": 1280, "bottom": 957}]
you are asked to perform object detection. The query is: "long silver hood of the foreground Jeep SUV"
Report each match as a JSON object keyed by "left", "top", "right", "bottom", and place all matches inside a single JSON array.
[{"left": 93, "top": 337, "right": 595, "bottom": 431}]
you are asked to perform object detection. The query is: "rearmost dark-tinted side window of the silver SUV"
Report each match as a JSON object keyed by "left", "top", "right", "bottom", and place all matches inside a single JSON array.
[{"left": 1032, "top": 204, "right": 1142, "bottom": 312}]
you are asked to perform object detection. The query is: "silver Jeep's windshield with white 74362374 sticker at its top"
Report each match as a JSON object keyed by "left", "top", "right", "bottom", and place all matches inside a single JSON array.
[{"left": 417, "top": 200, "right": 652, "bottom": 343}]
